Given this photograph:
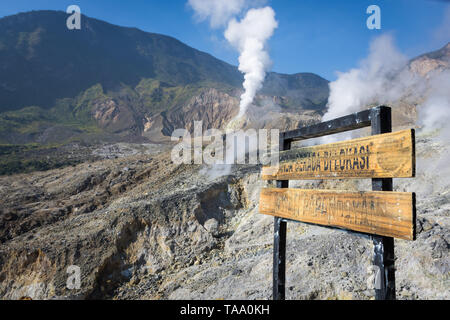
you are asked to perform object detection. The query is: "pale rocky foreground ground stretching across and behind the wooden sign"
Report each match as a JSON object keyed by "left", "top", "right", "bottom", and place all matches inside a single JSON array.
[{"left": 0, "top": 133, "right": 450, "bottom": 299}]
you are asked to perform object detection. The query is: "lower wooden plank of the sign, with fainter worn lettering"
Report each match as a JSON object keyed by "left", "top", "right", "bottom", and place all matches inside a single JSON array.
[{"left": 259, "top": 188, "right": 416, "bottom": 240}]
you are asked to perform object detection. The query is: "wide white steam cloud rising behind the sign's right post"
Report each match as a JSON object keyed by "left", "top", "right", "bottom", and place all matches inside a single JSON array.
[{"left": 323, "top": 35, "right": 450, "bottom": 137}]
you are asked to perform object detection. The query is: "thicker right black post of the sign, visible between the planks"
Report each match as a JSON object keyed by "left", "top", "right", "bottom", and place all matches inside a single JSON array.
[{"left": 370, "top": 106, "right": 395, "bottom": 300}]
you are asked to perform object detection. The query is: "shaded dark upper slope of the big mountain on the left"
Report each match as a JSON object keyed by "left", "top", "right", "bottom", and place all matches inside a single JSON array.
[{"left": 0, "top": 11, "right": 246, "bottom": 111}]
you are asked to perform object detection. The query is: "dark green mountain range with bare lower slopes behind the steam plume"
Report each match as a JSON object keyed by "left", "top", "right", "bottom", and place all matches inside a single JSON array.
[{"left": 0, "top": 11, "right": 329, "bottom": 144}]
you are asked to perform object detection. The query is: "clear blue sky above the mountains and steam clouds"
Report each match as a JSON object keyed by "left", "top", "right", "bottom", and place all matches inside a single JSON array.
[{"left": 0, "top": 0, "right": 450, "bottom": 80}]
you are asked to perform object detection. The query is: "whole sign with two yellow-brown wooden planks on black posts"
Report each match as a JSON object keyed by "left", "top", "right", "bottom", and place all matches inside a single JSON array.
[{"left": 260, "top": 106, "right": 416, "bottom": 300}]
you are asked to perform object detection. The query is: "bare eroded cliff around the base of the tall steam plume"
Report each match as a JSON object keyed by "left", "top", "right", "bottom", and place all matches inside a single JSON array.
[{"left": 142, "top": 88, "right": 320, "bottom": 141}]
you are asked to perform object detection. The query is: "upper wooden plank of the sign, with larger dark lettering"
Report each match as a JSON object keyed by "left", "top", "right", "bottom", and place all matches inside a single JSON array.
[{"left": 262, "top": 129, "right": 415, "bottom": 180}]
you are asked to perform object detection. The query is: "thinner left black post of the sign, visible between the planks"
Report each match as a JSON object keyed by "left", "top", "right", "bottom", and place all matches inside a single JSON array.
[{"left": 273, "top": 133, "right": 291, "bottom": 300}]
